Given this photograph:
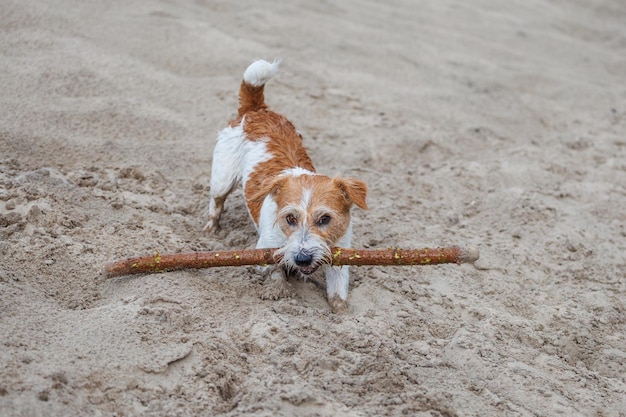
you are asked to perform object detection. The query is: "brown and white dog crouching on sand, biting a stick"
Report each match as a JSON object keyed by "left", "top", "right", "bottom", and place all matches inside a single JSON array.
[{"left": 205, "top": 60, "right": 367, "bottom": 313}]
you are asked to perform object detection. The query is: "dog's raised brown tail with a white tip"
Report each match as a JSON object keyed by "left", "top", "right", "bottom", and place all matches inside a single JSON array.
[{"left": 239, "top": 59, "right": 279, "bottom": 117}]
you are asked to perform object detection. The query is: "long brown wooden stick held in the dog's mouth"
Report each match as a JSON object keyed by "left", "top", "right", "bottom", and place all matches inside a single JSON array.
[{"left": 104, "top": 246, "right": 478, "bottom": 278}]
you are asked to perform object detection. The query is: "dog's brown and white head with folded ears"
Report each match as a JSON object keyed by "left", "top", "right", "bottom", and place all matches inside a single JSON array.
[{"left": 269, "top": 174, "right": 367, "bottom": 275}]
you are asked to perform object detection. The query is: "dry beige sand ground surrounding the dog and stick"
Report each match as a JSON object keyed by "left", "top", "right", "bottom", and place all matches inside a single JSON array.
[{"left": 0, "top": 0, "right": 626, "bottom": 417}]
